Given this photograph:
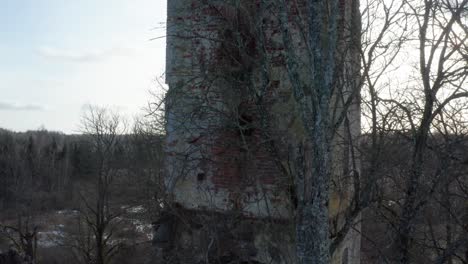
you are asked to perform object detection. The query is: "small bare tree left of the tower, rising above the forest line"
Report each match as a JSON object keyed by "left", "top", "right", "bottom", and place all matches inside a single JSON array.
[{"left": 71, "top": 106, "right": 126, "bottom": 264}]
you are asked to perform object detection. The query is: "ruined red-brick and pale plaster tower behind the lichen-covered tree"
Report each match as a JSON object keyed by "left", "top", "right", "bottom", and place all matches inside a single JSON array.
[{"left": 163, "top": 0, "right": 360, "bottom": 263}]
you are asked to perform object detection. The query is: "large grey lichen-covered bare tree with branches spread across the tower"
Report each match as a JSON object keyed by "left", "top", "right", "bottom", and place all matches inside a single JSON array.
[{"left": 167, "top": 0, "right": 361, "bottom": 263}]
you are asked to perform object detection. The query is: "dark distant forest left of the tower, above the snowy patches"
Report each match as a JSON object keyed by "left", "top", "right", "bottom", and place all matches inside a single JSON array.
[{"left": 0, "top": 129, "right": 162, "bottom": 212}]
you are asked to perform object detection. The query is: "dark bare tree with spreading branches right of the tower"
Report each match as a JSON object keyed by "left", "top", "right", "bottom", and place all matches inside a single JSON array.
[{"left": 356, "top": 1, "right": 468, "bottom": 263}]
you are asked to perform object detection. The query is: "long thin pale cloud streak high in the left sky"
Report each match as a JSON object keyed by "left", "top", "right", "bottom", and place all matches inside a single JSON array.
[{"left": 37, "top": 46, "right": 134, "bottom": 62}]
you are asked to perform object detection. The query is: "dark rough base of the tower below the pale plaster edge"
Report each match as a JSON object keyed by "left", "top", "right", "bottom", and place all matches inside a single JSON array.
[{"left": 155, "top": 207, "right": 294, "bottom": 264}]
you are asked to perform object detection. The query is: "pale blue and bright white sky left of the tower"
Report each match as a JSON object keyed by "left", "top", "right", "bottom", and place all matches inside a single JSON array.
[{"left": 0, "top": 0, "right": 166, "bottom": 133}]
